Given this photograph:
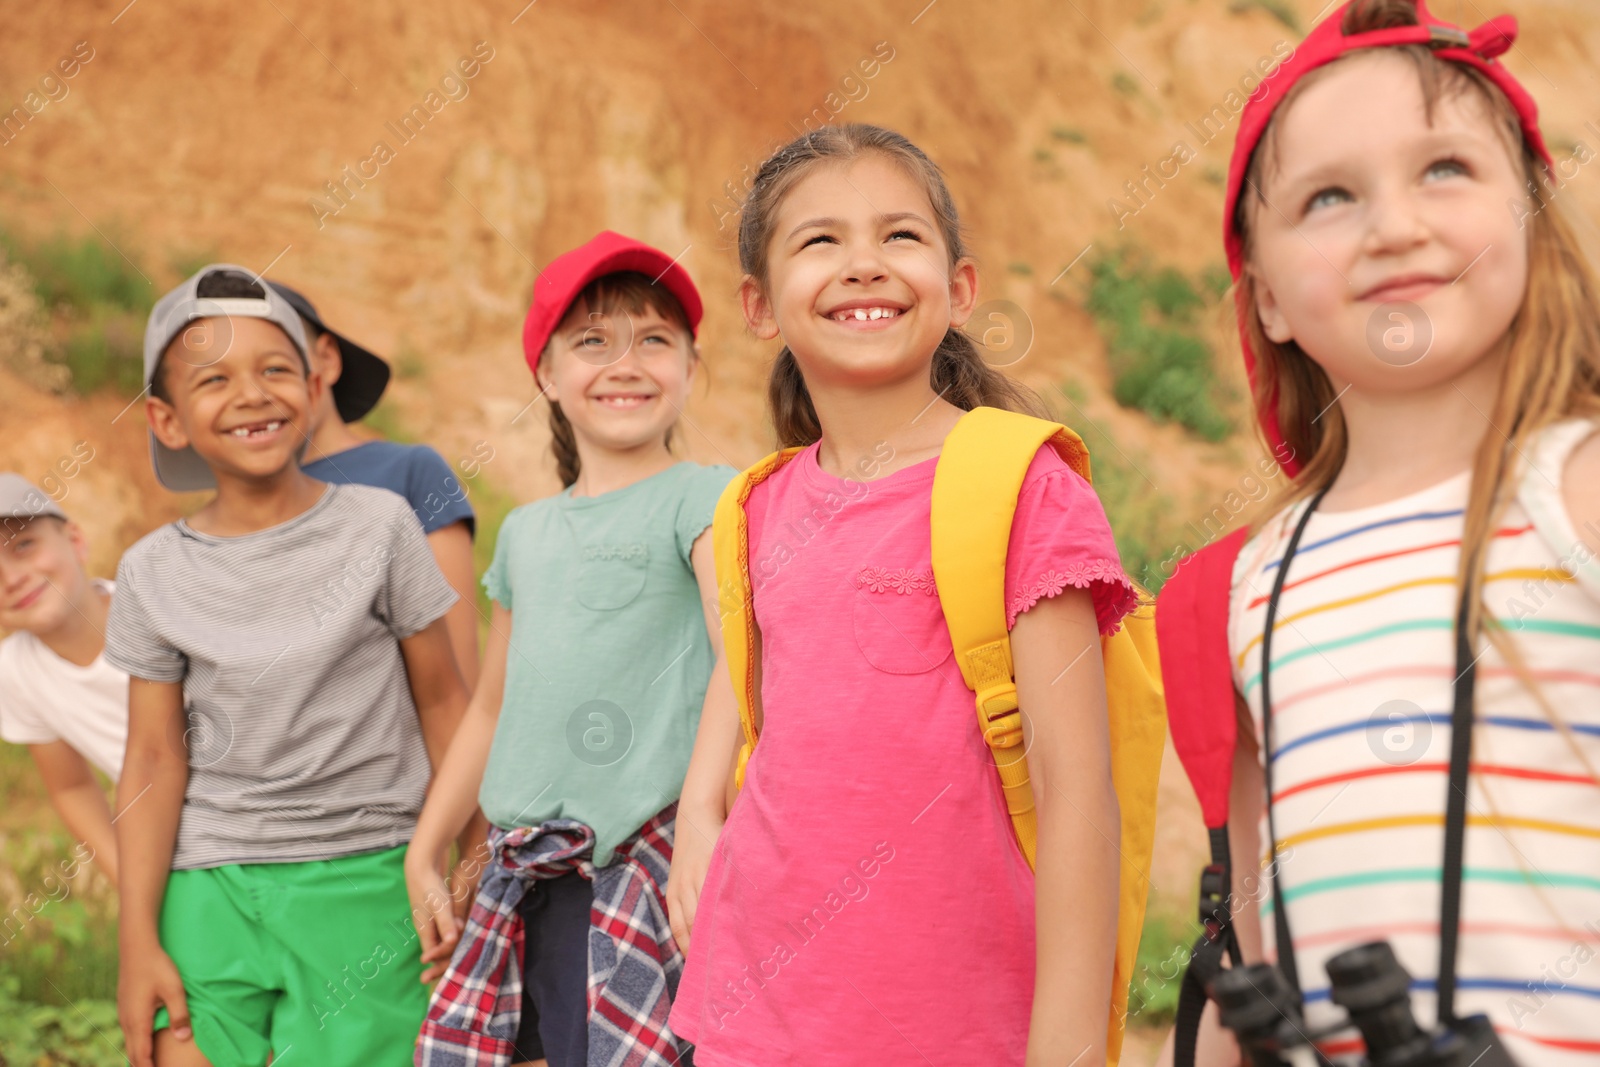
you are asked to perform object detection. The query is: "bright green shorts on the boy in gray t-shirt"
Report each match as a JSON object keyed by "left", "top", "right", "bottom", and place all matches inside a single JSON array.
[{"left": 154, "top": 846, "right": 429, "bottom": 1067}]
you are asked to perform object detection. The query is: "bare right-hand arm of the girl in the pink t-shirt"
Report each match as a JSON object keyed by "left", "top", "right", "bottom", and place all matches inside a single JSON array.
[{"left": 1011, "top": 589, "right": 1122, "bottom": 1067}]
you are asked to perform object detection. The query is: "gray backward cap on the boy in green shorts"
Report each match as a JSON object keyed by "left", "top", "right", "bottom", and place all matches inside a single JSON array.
[{"left": 144, "top": 262, "right": 309, "bottom": 493}]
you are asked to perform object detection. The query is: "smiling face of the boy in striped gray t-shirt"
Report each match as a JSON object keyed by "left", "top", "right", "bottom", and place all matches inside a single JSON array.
[{"left": 146, "top": 317, "right": 320, "bottom": 480}]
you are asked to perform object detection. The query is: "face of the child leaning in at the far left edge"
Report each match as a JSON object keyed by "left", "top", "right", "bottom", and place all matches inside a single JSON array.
[{"left": 0, "top": 517, "right": 88, "bottom": 633}]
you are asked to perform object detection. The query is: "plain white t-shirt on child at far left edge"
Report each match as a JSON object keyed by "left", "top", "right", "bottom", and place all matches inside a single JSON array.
[{"left": 0, "top": 579, "right": 128, "bottom": 781}]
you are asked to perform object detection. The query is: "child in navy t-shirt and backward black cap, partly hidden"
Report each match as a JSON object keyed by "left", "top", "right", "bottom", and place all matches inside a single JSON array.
[{"left": 267, "top": 280, "right": 476, "bottom": 691}]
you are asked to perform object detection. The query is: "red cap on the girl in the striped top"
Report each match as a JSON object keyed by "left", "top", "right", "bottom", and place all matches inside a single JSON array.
[{"left": 1222, "top": 0, "right": 1555, "bottom": 477}]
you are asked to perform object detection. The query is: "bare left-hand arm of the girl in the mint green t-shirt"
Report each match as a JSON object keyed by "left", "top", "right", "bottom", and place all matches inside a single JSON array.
[{"left": 405, "top": 605, "right": 512, "bottom": 982}]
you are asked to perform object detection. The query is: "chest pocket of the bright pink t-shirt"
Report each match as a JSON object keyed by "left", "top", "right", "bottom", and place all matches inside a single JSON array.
[{"left": 851, "top": 566, "right": 952, "bottom": 675}]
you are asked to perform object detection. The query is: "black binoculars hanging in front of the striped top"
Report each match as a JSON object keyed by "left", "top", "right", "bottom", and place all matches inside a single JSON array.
[{"left": 1208, "top": 941, "right": 1515, "bottom": 1067}]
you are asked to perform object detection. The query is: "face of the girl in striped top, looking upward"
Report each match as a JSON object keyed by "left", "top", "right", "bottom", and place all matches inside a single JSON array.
[{"left": 1245, "top": 51, "right": 1528, "bottom": 390}]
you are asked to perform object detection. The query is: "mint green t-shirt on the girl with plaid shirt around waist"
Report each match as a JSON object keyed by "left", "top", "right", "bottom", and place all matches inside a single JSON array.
[{"left": 478, "top": 462, "right": 734, "bottom": 867}]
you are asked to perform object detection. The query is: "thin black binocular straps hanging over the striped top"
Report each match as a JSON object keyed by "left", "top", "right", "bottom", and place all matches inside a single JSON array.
[{"left": 1261, "top": 486, "right": 1477, "bottom": 1024}]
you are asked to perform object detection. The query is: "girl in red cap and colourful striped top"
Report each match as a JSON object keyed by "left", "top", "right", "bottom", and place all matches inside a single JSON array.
[{"left": 1162, "top": 0, "right": 1600, "bottom": 1067}]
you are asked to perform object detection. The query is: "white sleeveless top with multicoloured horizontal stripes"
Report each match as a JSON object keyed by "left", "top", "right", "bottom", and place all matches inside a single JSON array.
[{"left": 1229, "top": 421, "right": 1600, "bottom": 1067}]
